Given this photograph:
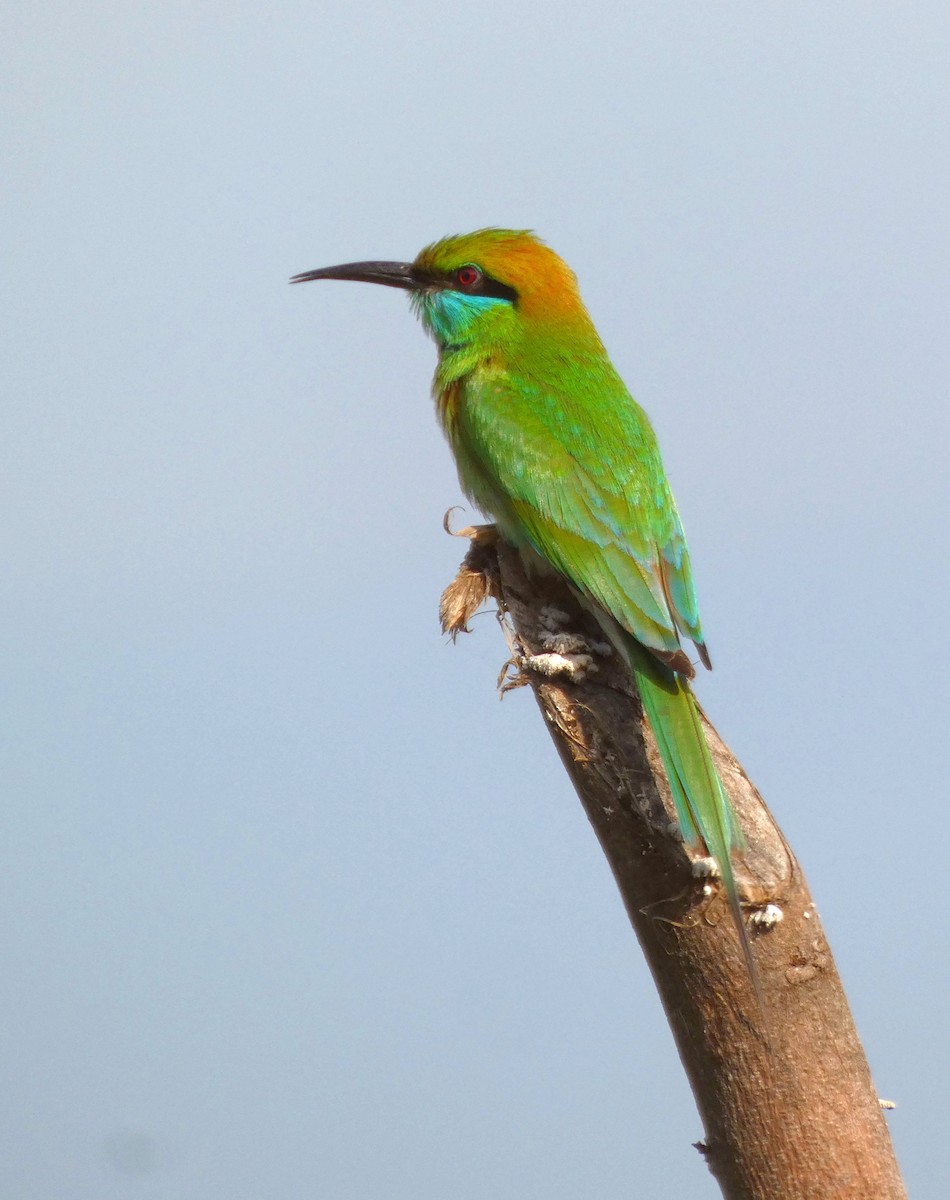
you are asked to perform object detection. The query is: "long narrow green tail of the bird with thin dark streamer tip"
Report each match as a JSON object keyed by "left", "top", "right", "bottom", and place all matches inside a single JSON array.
[{"left": 626, "top": 638, "right": 764, "bottom": 1015}]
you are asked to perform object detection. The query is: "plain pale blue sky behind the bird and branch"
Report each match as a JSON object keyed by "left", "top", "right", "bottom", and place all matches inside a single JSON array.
[{"left": 0, "top": 0, "right": 950, "bottom": 1200}]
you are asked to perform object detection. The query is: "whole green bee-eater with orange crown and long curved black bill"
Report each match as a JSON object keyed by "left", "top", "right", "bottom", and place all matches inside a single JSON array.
[{"left": 291, "top": 229, "right": 759, "bottom": 992}]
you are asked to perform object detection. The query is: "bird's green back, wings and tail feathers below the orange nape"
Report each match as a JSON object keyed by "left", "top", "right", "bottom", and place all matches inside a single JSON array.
[{"left": 444, "top": 324, "right": 739, "bottom": 912}]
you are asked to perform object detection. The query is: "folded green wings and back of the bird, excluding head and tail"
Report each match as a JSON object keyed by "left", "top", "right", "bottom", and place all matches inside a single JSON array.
[{"left": 450, "top": 365, "right": 708, "bottom": 673}]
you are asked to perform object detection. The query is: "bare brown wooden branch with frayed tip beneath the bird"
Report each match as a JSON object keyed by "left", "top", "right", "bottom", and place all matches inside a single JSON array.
[{"left": 443, "top": 537, "right": 906, "bottom": 1200}]
